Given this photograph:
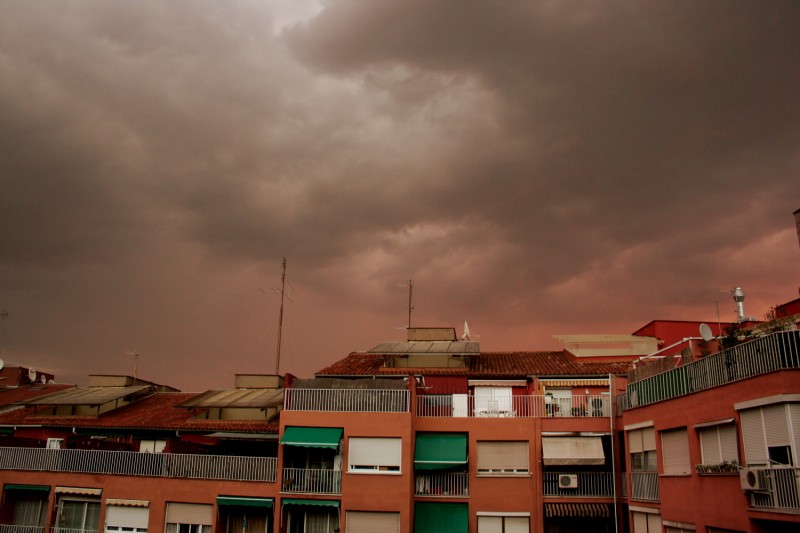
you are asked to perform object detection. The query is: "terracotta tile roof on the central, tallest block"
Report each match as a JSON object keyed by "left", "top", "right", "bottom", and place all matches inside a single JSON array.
[{"left": 317, "top": 350, "right": 630, "bottom": 378}]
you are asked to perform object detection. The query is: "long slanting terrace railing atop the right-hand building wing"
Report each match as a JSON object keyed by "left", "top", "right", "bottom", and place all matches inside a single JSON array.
[{"left": 622, "top": 331, "right": 800, "bottom": 409}]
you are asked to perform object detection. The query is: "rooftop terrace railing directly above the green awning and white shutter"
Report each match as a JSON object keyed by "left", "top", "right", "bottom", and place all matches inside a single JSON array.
[{"left": 283, "top": 389, "right": 409, "bottom": 413}]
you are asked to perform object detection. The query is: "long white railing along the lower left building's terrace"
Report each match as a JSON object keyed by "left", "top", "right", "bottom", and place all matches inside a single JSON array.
[{"left": 0, "top": 448, "right": 278, "bottom": 482}]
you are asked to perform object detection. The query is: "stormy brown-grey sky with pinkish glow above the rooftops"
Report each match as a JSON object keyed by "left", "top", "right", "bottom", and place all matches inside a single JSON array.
[{"left": 0, "top": 0, "right": 800, "bottom": 391}]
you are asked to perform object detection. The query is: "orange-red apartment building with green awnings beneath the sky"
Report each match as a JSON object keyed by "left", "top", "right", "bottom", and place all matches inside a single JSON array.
[{"left": 0, "top": 302, "right": 800, "bottom": 533}]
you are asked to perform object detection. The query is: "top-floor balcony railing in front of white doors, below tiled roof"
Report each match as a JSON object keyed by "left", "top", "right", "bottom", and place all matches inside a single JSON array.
[{"left": 417, "top": 394, "right": 611, "bottom": 418}]
